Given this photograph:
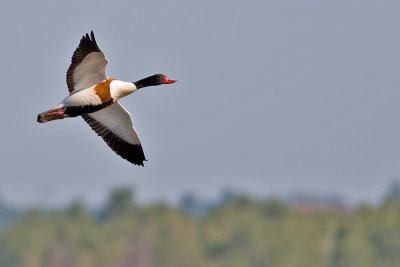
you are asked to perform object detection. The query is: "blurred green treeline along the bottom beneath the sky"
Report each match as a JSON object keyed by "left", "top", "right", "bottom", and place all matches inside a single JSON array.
[{"left": 0, "top": 189, "right": 400, "bottom": 267}]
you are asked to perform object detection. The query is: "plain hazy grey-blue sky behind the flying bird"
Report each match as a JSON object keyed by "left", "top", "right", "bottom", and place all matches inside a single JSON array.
[{"left": 0, "top": 0, "right": 400, "bottom": 205}]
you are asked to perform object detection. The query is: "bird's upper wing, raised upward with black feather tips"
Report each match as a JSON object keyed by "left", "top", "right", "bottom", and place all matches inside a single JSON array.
[{"left": 67, "top": 31, "right": 108, "bottom": 94}]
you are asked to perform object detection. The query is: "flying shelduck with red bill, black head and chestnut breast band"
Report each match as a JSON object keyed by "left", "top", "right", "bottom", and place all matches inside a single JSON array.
[{"left": 37, "top": 31, "right": 176, "bottom": 166}]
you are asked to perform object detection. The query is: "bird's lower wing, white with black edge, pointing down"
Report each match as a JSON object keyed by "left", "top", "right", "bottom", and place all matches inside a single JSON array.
[{"left": 82, "top": 102, "right": 146, "bottom": 166}]
